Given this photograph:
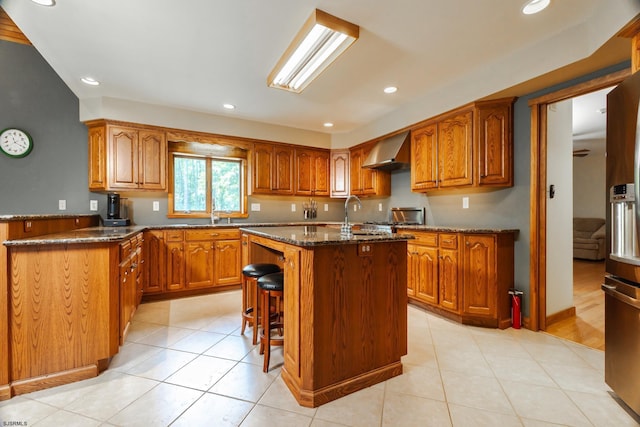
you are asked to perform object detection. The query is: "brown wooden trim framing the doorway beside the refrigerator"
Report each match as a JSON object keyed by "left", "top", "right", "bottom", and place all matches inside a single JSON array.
[{"left": 527, "top": 69, "right": 631, "bottom": 331}]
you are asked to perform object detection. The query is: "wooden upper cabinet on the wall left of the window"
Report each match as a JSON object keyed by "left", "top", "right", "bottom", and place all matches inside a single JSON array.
[{"left": 87, "top": 120, "right": 167, "bottom": 191}]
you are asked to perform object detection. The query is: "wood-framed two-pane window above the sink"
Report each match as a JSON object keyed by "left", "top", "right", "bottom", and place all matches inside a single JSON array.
[{"left": 169, "top": 152, "right": 246, "bottom": 217}]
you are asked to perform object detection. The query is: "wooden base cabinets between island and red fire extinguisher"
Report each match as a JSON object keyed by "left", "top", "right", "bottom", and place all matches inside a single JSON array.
[{"left": 399, "top": 230, "right": 514, "bottom": 329}]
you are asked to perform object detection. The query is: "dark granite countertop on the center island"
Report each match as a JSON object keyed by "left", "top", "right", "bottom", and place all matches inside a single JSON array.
[{"left": 240, "top": 225, "right": 411, "bottom": 246}]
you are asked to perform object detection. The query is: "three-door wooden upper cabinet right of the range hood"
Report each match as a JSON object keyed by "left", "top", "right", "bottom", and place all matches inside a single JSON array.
[{"left": 411, "top": 98, "right": 514, "bottom": 192}]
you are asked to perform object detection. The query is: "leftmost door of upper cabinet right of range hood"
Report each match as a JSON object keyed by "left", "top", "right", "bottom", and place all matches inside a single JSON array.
[{"left": 411, "top": 123, "right": 438, "bottom": 191}]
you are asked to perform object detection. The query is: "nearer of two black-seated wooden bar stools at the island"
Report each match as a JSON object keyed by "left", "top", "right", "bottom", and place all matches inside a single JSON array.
[{"left": 258, "top": 272, "right": 284, "bottom": 372}]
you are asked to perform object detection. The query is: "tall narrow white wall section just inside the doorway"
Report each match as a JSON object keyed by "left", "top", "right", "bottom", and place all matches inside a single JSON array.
[{"left": 546, "top": 99, "right": 573, "bottom": 316}]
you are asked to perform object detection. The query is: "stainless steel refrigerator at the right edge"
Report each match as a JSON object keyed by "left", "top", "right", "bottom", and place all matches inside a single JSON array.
[{"left": 602, "top": 73, "right": 640, "bottom": 413}]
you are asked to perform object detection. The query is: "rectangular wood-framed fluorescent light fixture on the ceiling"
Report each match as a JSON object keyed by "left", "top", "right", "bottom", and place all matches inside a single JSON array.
[{"left": 267, "top": 9, "right": 360, "bottom": 93}]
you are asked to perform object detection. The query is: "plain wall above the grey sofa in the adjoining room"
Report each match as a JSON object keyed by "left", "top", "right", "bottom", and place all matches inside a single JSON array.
[{"left": 573, "top": 149, "right": 607, "bottom": 218}]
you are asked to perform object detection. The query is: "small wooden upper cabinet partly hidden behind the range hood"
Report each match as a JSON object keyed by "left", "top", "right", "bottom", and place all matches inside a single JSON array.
[{"left": 349, "top": 143, "right": 391, "bottom": 196}]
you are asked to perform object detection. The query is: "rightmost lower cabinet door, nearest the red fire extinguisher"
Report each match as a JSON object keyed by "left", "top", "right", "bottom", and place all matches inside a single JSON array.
[{"left": 462, "top": 235, "right": 498, "bottom": 317}]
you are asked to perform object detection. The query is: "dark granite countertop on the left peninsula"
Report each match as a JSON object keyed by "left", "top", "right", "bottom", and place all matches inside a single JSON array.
[{"left": 3, "top": 226, "right": 146, "bottom": 246}]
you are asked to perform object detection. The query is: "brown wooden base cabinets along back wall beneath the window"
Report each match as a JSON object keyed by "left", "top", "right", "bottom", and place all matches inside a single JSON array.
[{"left": 145, "top": 228, "right": 242, "bottom": 295}]
